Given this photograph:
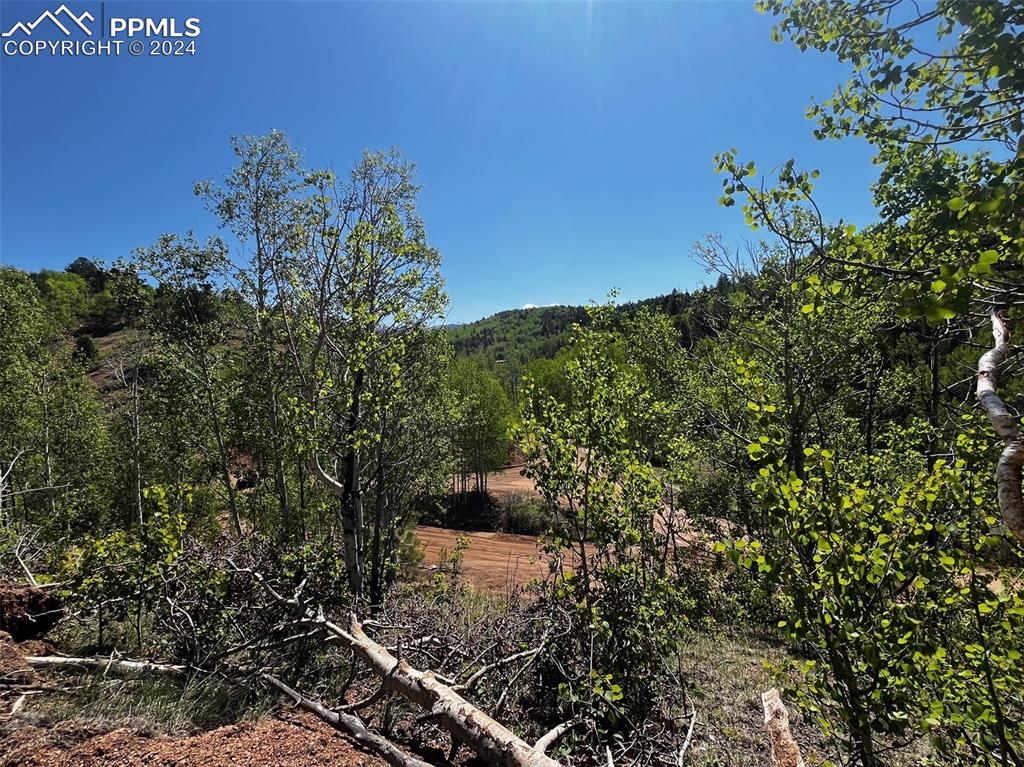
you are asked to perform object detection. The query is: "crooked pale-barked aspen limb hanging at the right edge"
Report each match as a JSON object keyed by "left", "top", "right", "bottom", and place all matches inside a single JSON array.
[{"left": 976, "top": 311, "right": 1024, "bottom": 541}]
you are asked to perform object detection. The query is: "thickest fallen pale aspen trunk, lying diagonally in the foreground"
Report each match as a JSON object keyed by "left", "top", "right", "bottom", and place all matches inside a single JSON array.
[{"left": 314, "top": 614, "right": 559, "bottom": 767}]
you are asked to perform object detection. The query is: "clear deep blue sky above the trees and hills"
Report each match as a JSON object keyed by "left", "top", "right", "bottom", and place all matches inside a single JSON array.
[{"left": 0, "top": 0, "right": 876, "bottom": 322}]
